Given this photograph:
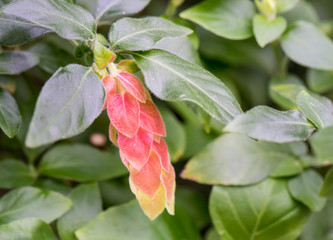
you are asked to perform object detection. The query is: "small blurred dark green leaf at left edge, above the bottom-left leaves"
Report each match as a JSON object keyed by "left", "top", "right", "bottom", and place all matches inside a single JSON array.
[{"left": 0, "top": 159, "right": 36, "bottom": 188}]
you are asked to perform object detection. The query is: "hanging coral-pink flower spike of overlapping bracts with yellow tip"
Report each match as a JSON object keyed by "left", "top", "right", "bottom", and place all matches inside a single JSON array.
[{"left": 102, "top": 68, "right": 176, "bottom": 220}]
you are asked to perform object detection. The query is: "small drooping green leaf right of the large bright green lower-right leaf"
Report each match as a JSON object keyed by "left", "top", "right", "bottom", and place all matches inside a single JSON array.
[{"left": 288, "top": 170, "right": 326, "bottom": 212}]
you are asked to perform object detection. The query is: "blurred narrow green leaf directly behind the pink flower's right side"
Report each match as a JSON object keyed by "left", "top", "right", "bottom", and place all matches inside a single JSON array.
[{"left": 160, "top": 109, "right": 186, "bottom": 162}]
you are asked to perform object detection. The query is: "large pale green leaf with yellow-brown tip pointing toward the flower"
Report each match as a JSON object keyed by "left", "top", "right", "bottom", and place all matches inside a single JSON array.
[{"left": 182, "top": 134, "right": 292, "bottom": 185}]
